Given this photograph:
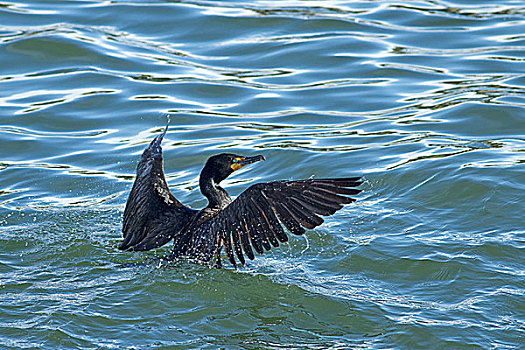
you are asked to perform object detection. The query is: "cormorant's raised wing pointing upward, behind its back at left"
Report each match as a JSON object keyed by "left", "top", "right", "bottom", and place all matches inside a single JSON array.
[{"left": 119, "top": 126, "right": 197, "bottom": 250}]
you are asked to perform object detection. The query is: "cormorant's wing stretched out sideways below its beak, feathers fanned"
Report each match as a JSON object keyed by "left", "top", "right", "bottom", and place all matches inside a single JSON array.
[{"left": 210, "top": 177, "right": 362, "bottom": 266}]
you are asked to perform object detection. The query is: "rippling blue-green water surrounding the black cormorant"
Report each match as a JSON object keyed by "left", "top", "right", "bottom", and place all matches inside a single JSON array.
[{"left": 0, "top": 0, "right": 525, "bottom": 349}]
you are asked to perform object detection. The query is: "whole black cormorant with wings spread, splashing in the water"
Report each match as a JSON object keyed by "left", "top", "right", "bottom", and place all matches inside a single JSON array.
[{"left": 119, "top": 126, "right": 362, "bottom": 267}]
